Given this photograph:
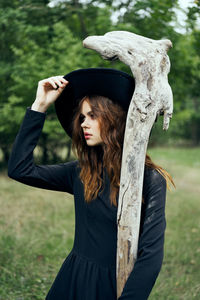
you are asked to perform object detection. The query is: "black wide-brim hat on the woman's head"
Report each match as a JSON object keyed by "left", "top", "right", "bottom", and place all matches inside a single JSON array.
[{"left": 55, "top": 68, "right": 135, "bottom": 137}]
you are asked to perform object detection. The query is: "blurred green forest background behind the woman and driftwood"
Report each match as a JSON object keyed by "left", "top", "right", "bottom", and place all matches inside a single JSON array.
[{"left": 0, "top": 0, "right": 200, "bottom": 168}]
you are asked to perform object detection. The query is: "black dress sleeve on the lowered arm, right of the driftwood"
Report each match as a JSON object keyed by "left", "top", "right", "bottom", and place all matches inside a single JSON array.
[{"left": 118, "top": 169, "right": 166, "bottom": 300}]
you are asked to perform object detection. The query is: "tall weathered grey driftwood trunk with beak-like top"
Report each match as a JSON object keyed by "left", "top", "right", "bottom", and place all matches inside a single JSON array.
[{"left": 83, "top": 31, "right": 173, "bottom": 297}]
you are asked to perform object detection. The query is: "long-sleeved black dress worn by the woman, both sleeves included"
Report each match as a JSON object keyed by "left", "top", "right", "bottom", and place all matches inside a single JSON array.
[{"left": 8, "top": 108, "right": 166, "bottom": 300}]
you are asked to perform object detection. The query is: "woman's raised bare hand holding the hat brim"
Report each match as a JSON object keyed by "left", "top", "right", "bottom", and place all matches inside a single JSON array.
[{"left": 31, "top": 76, "right": 69, "bottom": 112}]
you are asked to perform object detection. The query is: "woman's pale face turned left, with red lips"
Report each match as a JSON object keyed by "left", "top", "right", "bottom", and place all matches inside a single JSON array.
[{"left": 80, "top": 100, "right": 103, "bottom": 146}]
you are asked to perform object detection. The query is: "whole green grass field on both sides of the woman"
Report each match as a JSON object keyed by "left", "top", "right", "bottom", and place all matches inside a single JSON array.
[{"left": 0, "top": 148, "right": 200, "bottom": 300}]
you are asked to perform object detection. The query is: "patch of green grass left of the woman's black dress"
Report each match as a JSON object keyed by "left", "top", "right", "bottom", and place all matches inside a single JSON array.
[{"left": 0, "top": 176, "right": 74, "bottom": 300}]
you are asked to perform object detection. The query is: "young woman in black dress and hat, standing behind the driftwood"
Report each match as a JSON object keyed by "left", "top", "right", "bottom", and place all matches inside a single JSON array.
[{"left": 8, "top": 68, "right": 173, "bottom": 300}]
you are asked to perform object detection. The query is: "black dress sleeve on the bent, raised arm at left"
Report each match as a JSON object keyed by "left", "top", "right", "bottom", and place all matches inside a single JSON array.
[{"left": 8, "top": 107, "right": 77, "bottom": 194}]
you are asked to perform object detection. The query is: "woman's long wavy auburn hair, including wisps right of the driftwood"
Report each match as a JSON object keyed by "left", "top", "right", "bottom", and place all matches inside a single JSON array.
[{"left": 72, "top": 95, "right": 175, "bottom": 206}]
